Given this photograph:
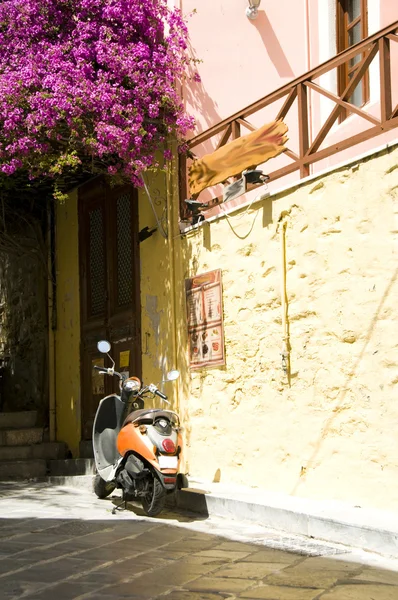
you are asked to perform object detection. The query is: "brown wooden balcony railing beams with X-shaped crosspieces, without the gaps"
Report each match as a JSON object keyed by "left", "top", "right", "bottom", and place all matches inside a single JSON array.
[{"left": 180, "top": 21, "right": 398, "bottom": 214}]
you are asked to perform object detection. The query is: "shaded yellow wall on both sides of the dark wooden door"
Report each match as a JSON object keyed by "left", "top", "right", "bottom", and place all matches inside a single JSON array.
[{"left": 54, "top": 172, "right": 178, "bottom": 456}]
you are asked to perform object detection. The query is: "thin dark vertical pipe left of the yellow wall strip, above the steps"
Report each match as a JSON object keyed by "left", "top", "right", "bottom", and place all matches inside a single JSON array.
[{"left": 47, "top": 199, "right": 57, "bottom": 442}]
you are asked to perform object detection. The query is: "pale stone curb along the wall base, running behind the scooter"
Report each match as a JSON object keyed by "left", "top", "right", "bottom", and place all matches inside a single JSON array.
[{"left": 42, "top": 475, "right": 398, "bottom": 557}]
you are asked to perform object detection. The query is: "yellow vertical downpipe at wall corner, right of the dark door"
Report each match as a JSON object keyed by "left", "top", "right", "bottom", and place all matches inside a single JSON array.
[{"left": 166, "top": 150, "right": 180, "bottom": 412}]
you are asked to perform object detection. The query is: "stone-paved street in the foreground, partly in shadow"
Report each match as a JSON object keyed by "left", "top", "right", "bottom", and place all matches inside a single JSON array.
[{"left": 0, "top": 483, "right": 398, "bottom": 600}]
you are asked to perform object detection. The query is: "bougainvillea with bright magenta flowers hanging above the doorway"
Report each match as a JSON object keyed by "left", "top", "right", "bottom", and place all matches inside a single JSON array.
[{"left": 0, "top": 0, "right": 192, "bottom": 195}]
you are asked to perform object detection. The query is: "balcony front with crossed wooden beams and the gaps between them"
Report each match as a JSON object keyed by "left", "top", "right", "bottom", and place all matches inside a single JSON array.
[{"left": 180, "top": 21, "right": 398, "bottom": 217}]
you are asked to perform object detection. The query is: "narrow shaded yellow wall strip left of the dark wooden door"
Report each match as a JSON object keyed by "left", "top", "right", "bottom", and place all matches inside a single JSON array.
[{"left": 55, "top": 191, "right": 81, "bottom": 456}]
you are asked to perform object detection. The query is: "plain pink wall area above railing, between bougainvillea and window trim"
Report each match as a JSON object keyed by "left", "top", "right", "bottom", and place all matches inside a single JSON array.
[{"left": 182, "top": 0, "right": 307, "bottom": 133}]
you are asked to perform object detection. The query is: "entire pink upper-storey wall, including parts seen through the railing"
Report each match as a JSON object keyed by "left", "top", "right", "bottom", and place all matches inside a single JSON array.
[{"left": 181, "top": 0, "right": 398, "bottom": 201}]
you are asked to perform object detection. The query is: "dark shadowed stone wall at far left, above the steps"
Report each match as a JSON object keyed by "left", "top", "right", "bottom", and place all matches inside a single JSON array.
[{"left": 0, "top": 219, "right": 48, "bottom": 423}]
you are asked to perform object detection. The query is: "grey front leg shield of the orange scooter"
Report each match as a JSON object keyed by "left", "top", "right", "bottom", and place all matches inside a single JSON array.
[{"left": 93, "top": 394, "right": 125, "bottom": 481}]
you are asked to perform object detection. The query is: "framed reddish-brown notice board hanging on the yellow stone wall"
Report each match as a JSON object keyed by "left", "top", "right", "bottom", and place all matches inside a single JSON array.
[{"left": 185, "top": 269, "right": 225, "bottom": 369}]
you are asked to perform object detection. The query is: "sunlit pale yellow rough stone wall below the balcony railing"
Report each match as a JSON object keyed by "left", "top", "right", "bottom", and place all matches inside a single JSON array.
[{"left": 179, "top": 149, "right": 398, "bottom": 508}]
